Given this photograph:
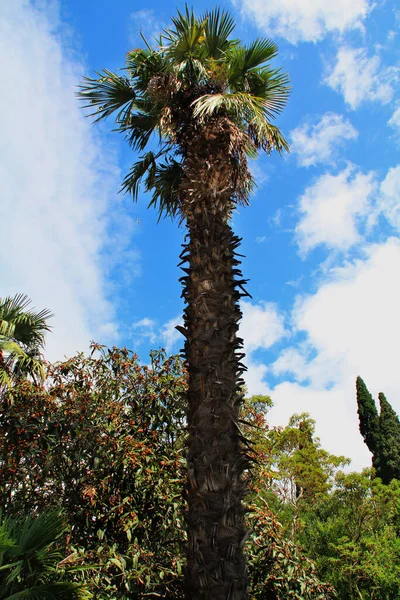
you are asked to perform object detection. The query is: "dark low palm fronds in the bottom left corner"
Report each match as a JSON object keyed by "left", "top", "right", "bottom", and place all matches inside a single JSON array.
[{"left": 0, "top": 511, "right": 92, "bottom": 600}]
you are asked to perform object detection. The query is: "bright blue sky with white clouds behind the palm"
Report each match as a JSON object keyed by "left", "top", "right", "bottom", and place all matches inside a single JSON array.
[{"left": 0, "top": 0, "right": 400, "bottom": 468}]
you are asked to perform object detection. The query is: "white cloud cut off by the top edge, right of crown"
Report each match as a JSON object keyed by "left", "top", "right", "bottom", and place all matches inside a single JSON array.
[{"left": 234, "top": 0, "right": 373, "bottom": 44}]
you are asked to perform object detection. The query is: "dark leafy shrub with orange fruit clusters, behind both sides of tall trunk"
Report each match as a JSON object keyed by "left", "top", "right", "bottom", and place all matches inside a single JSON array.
[{"left": 0, "top": 354, "right": 330, "bottom": 600}]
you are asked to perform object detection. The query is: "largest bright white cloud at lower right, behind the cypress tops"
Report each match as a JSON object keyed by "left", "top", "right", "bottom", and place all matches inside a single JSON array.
[{"left": 263, "top": 238, "right": 400, "bottom": 468}]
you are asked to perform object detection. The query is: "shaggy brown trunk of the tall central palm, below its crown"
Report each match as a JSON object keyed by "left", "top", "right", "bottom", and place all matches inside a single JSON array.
[{"left": 181, "top": 202, "right": 248, "bottom": 600}]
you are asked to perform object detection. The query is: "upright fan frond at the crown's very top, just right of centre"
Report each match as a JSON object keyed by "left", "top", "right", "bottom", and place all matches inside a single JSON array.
[{"left": 200, "top": 8, "right": 237, "bottom": 60}]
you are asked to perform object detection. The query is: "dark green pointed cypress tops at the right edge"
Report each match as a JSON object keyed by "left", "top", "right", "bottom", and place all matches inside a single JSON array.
[{"left": 356, "top": 377, "right": 400, "bottom": 484}]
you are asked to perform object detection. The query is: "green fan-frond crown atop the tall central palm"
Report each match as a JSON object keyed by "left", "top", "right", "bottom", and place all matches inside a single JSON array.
[{"left": 79, "top": 8, "right": 290, "bottom": 216}]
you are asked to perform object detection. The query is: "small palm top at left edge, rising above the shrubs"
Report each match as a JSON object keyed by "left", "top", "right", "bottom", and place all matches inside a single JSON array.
[{"left": 0, "top": 294, "right": 52, "bottom": 388}]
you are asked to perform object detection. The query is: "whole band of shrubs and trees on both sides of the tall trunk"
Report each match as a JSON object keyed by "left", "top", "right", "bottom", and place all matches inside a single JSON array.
[{"left": 0, "top": 345, "right": 400, "bottom": 600}]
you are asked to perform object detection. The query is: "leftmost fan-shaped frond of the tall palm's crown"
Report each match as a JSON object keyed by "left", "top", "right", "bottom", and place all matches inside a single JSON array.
[{"left": 77, "top": 69, "right": 136, "bottom": 123}]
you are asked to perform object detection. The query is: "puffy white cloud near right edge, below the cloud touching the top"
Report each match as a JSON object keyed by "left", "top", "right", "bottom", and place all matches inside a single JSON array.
[{"left": 325, "top": 46, "right": 398, "bottom": 109}]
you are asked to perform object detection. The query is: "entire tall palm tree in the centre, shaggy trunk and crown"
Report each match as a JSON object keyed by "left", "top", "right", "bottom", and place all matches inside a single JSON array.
[{"left": 79, "top": 8, "right": 289, "bottom": 600}]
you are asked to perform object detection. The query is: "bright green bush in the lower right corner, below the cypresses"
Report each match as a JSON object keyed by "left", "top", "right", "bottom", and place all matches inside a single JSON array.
[{"left": 298, "top": 470, "right": 400, "bottom": 600}]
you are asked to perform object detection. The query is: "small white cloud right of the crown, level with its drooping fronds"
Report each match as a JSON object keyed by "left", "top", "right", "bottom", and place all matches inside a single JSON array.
[{"left": 290, "top": 113, "right": 358, "bottom": 167}]
